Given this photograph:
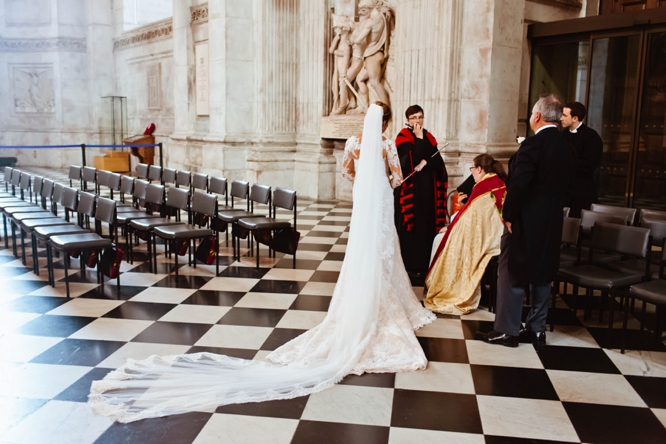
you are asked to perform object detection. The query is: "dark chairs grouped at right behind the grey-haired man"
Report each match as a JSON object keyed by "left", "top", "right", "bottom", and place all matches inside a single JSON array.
[{"left": 550, "top": 206, "right": 666, "bottom": 352}]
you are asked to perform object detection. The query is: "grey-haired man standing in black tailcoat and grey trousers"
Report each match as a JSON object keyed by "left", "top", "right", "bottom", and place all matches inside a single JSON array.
[{"left": 476, "top": 94, "right": 575, "bottom": 347}]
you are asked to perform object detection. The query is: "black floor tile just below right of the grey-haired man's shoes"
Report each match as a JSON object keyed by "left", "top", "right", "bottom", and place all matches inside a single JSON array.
[{"left": 538, "top": 346, "right": 620, "bottom": 375}]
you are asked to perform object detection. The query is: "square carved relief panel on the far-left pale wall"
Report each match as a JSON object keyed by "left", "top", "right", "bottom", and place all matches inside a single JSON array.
[{"left": 12, "top": 64, "right": 55, "bottom": 113}]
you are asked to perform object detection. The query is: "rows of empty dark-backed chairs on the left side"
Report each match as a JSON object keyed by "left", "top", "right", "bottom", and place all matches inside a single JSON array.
[{"left": 2, "top": 167, "right": 297, "bottom": 294}]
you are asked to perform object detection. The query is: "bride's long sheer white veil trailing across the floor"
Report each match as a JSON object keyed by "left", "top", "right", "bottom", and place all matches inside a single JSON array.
[{"left": 89, "top": 105, "right": 432, "bottom": 422}]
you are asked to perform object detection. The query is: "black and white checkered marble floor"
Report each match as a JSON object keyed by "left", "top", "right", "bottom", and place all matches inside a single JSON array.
[{"left": 0, "top": 168, "right": 666, "bottom": 444}]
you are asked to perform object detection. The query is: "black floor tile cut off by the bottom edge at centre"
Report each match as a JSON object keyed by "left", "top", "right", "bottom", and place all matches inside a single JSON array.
[{"left": 291, "top": 421, "right": 390, "bottom": 444}]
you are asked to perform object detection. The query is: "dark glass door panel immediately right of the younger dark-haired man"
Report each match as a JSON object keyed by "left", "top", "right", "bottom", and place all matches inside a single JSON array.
[{"left": 586, "top": 32, "right": 642, "bottom": 206}]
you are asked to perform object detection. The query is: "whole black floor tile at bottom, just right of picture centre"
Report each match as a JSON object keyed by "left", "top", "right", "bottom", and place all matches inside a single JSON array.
[{"left": 391, "top": 389, "right": 483, "bottom": 433}]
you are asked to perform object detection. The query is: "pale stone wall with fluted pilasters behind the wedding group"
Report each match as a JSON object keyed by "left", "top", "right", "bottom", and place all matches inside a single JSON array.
[{"left": 0, "top": 0, "right": 598, "bottom": 199}]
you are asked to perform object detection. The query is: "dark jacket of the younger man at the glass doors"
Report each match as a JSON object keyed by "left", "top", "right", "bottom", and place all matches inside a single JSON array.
[{"left": 562, "top": 124, "right": 604, "bottom": 217}]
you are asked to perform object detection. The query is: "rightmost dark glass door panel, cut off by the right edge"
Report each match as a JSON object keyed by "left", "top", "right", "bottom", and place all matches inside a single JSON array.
[{"left": 629, "top": 30, "right": 666, "bottom": 210}]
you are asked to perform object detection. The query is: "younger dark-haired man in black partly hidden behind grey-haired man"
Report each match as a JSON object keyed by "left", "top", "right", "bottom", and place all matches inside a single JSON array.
[{"left": 562, "top": 102, "right": 604, "bottom": 217}]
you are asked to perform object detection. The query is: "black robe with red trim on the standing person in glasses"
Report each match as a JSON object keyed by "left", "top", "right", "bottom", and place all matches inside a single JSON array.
[{"left": 394, "top": 128, "right": 448, "bottom": 272}]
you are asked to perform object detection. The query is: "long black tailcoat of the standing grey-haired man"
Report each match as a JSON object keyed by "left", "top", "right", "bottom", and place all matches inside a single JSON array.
[{"left": 503, "top": 128, "right": 576, "bottom": 285}]
